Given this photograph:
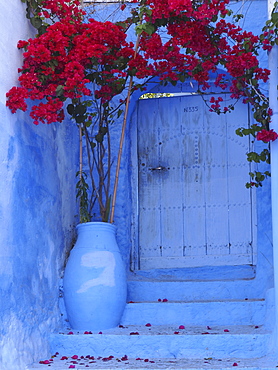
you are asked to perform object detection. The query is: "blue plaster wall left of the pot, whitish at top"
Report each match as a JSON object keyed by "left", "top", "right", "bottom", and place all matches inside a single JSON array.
[{"left": 0, "top": 0, "right": 77, "bottom": 370}]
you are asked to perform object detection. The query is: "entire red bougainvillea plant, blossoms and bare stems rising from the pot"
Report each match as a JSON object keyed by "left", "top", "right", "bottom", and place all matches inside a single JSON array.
[{"left": 7, "top": 0, "right": 278, "bottom": 222}]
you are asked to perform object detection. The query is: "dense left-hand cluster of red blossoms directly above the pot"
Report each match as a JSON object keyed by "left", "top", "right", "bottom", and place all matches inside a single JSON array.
[{"left": 7, "top": 8, "right": 136, "bottom": 124}]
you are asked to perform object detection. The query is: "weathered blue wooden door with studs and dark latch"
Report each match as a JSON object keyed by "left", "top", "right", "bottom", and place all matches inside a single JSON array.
[{"left": 137, "top": 95, "right": 254, "bottom": 269}]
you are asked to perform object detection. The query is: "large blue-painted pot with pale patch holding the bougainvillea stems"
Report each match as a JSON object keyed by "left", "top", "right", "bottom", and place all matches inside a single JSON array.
[{"left": 64, "top": 222, "right": 127, "bottom": 330}]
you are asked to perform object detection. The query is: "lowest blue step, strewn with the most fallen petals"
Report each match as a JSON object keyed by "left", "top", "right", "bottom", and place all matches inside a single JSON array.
[{"left": 27, "top": 354, "right": 278, "bottom": 370}]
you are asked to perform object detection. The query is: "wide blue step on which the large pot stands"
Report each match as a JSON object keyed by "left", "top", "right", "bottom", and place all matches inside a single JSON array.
[{"left": 47, "top": 325, "right": 271, "bottom": 359}]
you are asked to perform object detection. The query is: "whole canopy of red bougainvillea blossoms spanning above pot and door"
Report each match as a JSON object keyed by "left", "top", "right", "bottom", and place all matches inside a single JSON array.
[{"left": 6, "top": 0, "right": 277, "bottom": 191}]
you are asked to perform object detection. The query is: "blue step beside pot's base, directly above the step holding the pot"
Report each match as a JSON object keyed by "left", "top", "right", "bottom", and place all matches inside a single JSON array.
[{"left": 121, "top": 299, "right": 266, "bottom": 326}]
